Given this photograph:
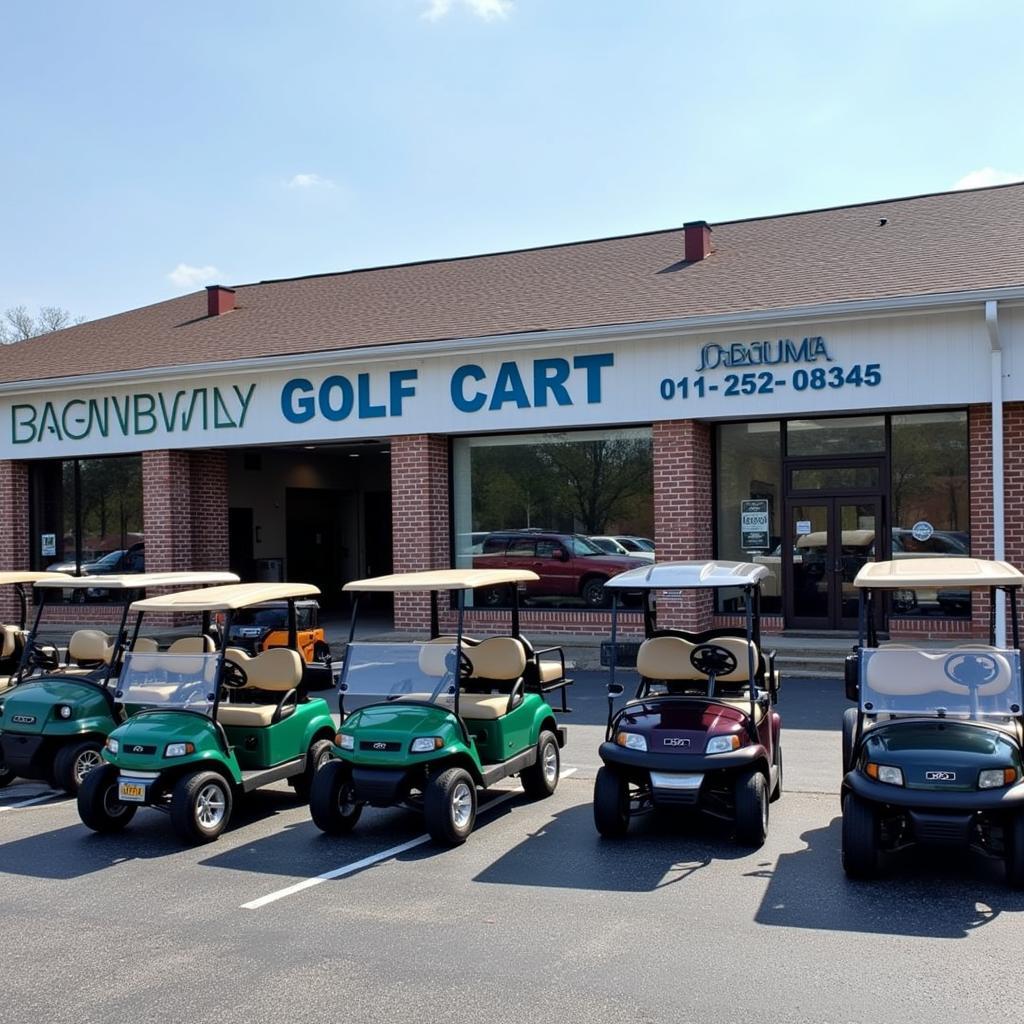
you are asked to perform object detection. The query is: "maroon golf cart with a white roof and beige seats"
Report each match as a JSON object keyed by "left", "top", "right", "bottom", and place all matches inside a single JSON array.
[{"left": 594, "top": 561, "right": 782, "bottom": 847}]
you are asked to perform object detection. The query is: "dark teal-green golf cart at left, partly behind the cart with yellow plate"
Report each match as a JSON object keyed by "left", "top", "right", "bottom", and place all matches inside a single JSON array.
[{"left": 0, "top": 572, "right": 238, "bottom": 795}]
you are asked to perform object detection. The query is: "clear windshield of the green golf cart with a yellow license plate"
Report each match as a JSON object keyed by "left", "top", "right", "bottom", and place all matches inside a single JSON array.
[{"left": 115, "top": 652, "right": 219, "bottom": 715}]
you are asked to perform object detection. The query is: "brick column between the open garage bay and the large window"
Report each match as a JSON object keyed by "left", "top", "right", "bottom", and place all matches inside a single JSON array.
[{"left": 391, "top": 434, "right": 452, "bottom": 631}]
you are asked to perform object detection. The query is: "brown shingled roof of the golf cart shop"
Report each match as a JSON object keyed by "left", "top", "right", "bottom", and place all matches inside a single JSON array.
[{"left": 0, "top": 184, "right": 1024, "bottom": 382}]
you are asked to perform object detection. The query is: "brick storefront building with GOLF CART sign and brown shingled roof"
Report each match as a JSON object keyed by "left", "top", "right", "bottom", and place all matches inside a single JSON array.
[{"left": 0, "top": 179, "right": 1024, "bottom": 636}]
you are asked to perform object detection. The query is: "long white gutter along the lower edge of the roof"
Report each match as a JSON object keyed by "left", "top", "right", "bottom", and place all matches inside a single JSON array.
[{"left": 0, "top": 287, "right": 1024, "bottom": 394}]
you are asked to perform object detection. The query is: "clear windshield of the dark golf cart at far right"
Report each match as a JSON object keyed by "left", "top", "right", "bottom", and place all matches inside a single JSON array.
[{"left": 860, "top": 645, "right": 1022, "bottom": 718}]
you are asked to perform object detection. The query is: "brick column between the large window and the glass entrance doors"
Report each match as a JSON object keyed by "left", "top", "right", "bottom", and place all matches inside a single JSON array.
[{"left": 651, "top": 420, "right": 714, "bottom": 631}]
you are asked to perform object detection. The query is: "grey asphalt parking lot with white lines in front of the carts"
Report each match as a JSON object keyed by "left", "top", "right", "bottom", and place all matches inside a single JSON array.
[{"left": 0, "top": 672, "right": 1024, "bottom": 1024}]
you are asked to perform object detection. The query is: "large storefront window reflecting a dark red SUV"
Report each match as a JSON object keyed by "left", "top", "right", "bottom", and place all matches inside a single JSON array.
[{"left": 453, "top": 429, "right": 654, "bottom": 608}]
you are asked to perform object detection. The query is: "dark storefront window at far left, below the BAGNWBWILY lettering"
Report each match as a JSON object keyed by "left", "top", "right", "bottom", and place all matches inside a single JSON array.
[{"left": 30, "top": 456, "right": 145, "bottom": 600}]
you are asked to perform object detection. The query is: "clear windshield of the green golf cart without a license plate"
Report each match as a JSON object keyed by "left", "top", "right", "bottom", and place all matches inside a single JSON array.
[{"left": 340, "top": 641, "right": 459, "bottom": 711}]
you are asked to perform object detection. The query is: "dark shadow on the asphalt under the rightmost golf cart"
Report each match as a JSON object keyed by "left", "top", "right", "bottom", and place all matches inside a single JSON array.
[{"left": 754, "top": 817, "right": 1024, "bottom": 939}]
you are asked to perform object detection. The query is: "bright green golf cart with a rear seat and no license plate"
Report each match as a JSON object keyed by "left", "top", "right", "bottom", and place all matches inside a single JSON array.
[{"left": 309, "top": 568, "right": 571, "bottom": 846}]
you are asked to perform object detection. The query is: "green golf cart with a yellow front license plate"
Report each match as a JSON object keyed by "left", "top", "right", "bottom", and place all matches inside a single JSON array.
[{"left": 78, "top": 583, "right": 335, "bottom": 843}]
